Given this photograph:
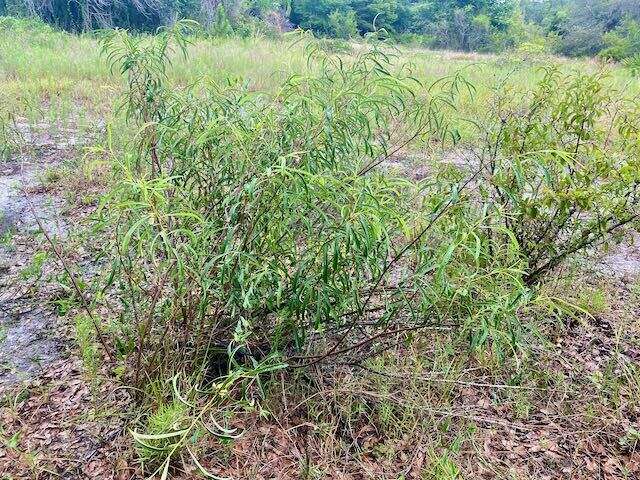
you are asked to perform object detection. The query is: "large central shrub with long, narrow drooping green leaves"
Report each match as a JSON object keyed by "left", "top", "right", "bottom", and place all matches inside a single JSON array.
[{"left": 99, "top": 27, "right": 523, "bottom": 380}]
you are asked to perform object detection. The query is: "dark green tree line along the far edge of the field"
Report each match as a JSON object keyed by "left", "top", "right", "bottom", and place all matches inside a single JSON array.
[{"left": 0, "top": 0, "right": 640, "bottom": 60}]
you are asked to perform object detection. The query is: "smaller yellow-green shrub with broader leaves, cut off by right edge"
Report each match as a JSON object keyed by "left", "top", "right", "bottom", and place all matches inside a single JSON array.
[{"left": 470, "top": 68, "right": 640, "bottom": 284}]
